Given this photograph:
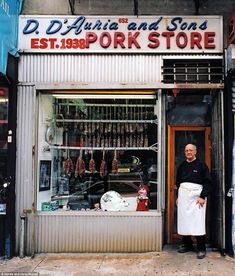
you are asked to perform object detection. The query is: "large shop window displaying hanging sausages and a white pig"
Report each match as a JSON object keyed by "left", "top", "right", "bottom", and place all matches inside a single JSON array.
[{"left": 37, "top": 94, "right": 158, "bottom": 212}]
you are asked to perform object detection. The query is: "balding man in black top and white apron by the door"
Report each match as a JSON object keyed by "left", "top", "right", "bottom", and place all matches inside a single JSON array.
[{"left": 176, "top": 144, "right": 212, "bottom": 259}]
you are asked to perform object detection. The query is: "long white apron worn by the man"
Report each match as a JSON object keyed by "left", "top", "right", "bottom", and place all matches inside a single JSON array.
[{"left": 177, "top": 182, "right": 206, "bottom": 236}]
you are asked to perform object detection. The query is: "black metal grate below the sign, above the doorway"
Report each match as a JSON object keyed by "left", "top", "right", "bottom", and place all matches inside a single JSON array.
[{"left": 162, "top": 59, "right": 224, "bottom": 83}]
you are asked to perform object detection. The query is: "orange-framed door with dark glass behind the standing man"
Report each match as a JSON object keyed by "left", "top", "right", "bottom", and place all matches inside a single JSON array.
[{"left": 167, "top": 125, "right": 211, "bottom": 244}]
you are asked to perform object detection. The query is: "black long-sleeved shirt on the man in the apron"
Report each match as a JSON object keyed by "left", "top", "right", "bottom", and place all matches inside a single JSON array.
[{"left": 176, "top": 159, "right": 212, "bottom": 198}]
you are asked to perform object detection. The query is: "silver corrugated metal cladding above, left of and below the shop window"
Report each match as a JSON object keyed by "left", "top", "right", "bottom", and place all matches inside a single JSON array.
[{"left": 16, "top": 55, "right": 162, "bottom": 254}]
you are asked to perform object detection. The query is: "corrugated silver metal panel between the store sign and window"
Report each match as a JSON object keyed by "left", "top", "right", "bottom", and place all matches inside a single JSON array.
[{"left": 19, "top": 54, "right": 161, "bottom": 84}]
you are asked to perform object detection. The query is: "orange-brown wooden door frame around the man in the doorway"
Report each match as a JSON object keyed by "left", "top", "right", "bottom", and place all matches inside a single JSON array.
[{"left": 167, "top": 125, "right": 211, "bottom": 244}]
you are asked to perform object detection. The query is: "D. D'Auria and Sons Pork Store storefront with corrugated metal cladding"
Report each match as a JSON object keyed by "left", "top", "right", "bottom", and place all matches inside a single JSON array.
[{"left": 16, "top": 16, "right": 224, "bottom": 254}]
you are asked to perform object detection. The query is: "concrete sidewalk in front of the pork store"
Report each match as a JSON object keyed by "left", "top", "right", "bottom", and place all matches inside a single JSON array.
[{"left": 0, "top": 247, "right": 235, "bottom": 276}]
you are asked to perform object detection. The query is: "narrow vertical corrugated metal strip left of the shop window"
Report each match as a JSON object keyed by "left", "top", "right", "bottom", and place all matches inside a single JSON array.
[{"left": 16, "top": 86, "right": 36, "bottom": 252}]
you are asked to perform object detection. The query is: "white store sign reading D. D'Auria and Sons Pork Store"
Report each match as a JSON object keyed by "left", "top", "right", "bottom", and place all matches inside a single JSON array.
[{"left": 19, "top": 16, "right": 223, "bottom": 53}]
